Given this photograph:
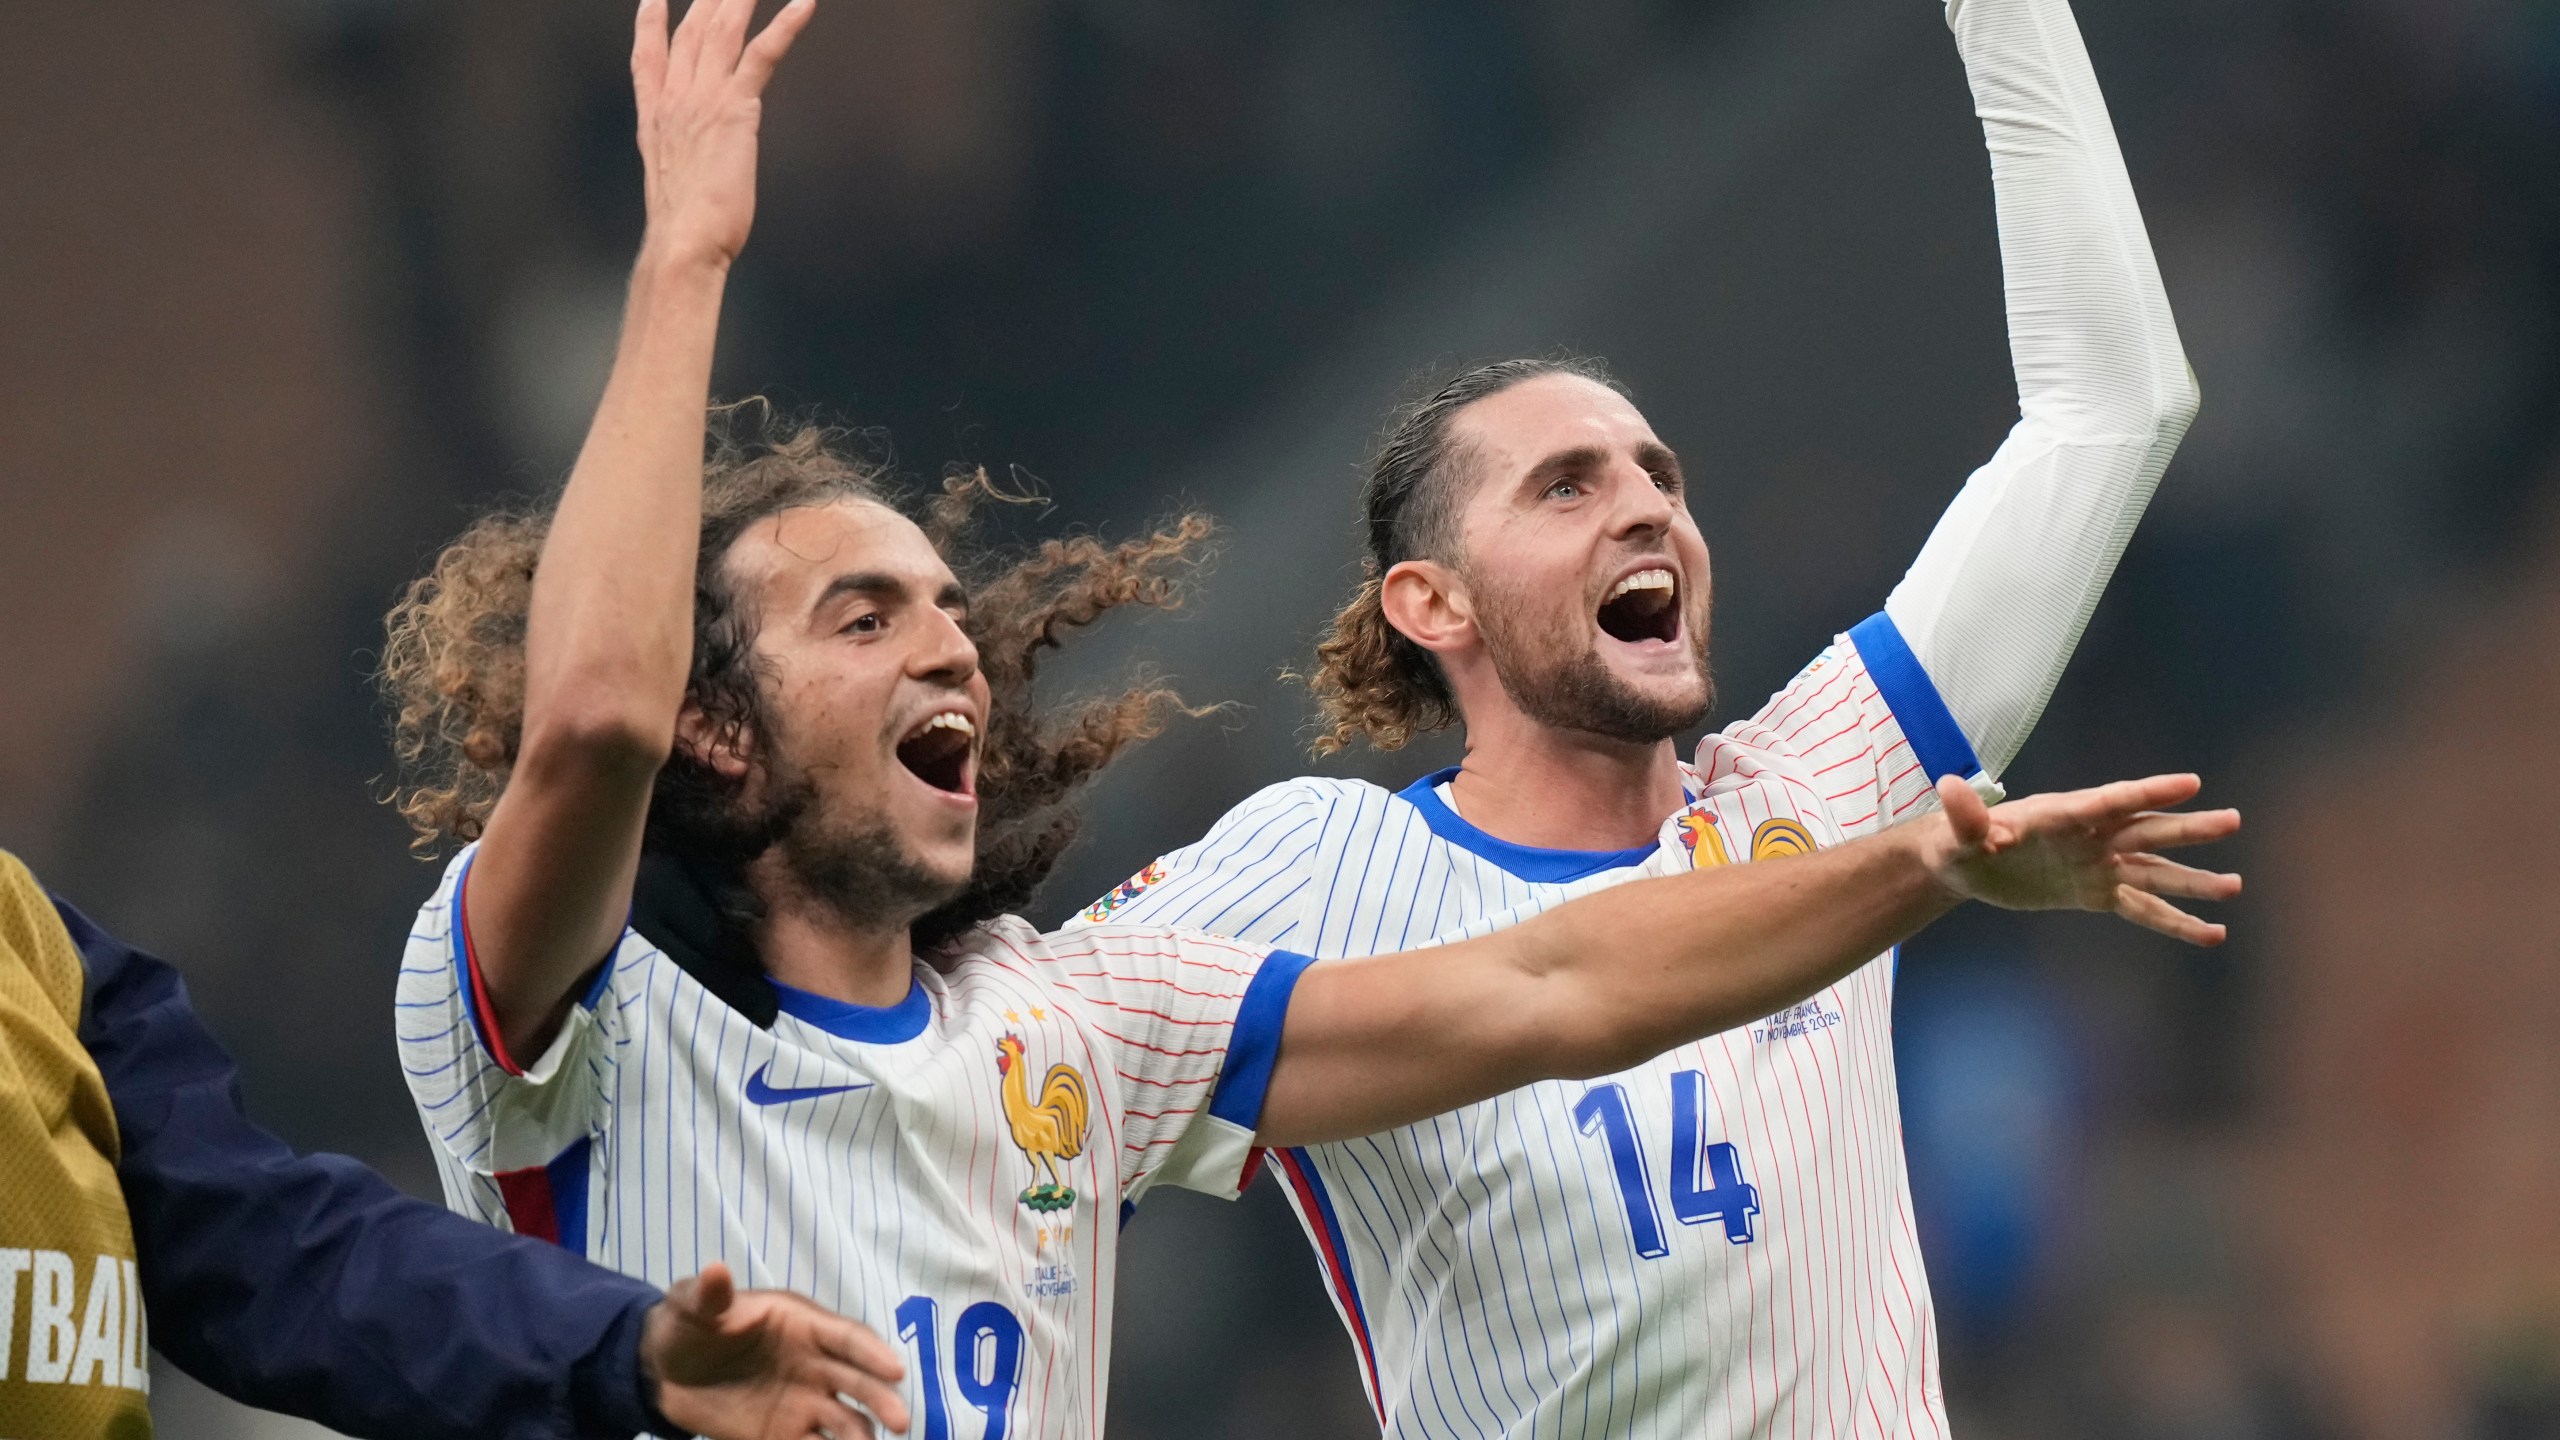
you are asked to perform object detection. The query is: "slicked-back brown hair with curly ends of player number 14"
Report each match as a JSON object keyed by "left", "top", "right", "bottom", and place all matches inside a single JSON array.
[{"left": 1308, "top": 356, "right": 1626, "bottom": 756}]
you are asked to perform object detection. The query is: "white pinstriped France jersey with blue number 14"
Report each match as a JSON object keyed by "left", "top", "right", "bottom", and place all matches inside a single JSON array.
[{"left": 1083, "top": 615, "right": 1976, "bottom": 1440}]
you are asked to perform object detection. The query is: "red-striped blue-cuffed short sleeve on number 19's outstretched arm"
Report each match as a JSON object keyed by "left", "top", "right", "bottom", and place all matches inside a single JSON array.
[{"left": 1050, "top": 925, "right": 1311, "bottom": 1199}]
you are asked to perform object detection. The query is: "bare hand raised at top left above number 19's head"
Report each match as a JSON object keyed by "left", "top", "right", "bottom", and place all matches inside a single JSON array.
[{"left": 632, "top": 0, "right": 817, "bottom": 264}]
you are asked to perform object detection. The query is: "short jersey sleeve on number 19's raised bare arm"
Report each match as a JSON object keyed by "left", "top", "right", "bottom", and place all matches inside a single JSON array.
[{"left": 394, "top": 848, "right": 632, "bottom": 1199}]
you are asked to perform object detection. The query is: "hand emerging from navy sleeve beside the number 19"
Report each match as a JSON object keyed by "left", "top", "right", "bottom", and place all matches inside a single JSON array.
[{"left": 640, "top": 1266, "right": 906, "bottom": 1440}]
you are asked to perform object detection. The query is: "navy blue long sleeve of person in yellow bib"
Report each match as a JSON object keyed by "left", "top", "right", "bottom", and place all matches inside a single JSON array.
[{"left": 54, "top": 899, "right": 671, "bottom": 1440}]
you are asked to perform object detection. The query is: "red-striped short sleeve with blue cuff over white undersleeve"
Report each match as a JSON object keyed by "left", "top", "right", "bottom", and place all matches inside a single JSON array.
[{"left": 1697, "top": 612, "right": 1981, "bottom": 838}]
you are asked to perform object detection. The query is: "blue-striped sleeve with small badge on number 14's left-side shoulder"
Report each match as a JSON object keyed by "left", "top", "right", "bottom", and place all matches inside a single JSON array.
[{"left": 1068, "top": 781, "right": 1329, "bottom": 945}]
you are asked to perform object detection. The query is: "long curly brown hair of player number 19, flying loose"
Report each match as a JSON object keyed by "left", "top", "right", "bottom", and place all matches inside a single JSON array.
[{"left": 376, "top": 402, "right": 1213, "bottom": 948}]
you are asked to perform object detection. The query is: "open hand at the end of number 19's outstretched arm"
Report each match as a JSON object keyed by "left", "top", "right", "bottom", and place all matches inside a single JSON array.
[{"left": 1928, "top": 774, "right": 2240, "bottom": 945}]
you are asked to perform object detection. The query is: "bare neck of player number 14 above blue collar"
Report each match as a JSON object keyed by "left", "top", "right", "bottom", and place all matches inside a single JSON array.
[{"left": 1449, "top": 715, "right": 1687, "bottom": 851}]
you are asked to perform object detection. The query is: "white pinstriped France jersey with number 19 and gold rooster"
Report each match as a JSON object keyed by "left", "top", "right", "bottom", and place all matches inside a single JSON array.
[{"left": 397, "top": 851, "right": 1306, "bottom": 1440}]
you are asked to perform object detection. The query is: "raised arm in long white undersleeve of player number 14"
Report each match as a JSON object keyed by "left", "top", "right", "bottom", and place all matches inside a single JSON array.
[{"left": 1884, "top": 0, "right": 2196, "bottom": 776}]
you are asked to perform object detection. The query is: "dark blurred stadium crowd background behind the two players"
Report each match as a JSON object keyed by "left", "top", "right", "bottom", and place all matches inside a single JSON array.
[{"left": 0, "top": 0, "right": 2560, "bottom": 1440}]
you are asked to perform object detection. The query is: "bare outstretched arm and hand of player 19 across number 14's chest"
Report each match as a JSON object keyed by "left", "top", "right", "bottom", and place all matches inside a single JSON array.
[{"left": 1257, "top": 776, "right": 2240, "bottom": 1145}]
